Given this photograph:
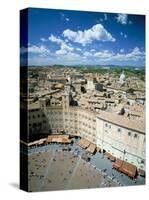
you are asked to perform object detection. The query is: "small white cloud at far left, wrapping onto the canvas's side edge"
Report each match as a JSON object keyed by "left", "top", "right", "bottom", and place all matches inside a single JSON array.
[{"left": 21, "top": 45, "right": 50, "bottom": 54}]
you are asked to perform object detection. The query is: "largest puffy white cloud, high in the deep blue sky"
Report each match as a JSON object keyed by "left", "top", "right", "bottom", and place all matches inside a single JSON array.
[{"left": 63, "top": 24, "right": 116, "bottom": 46}]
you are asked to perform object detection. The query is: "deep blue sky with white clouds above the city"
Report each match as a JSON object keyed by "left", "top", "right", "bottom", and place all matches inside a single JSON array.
[{"left": 21, "top": 8, "right": 145, "bottom": 66}]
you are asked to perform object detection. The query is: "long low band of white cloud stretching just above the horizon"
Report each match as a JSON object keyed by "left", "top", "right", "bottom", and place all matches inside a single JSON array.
[{"left": 29, "top": 47, "right": 145, "bottom": 64}]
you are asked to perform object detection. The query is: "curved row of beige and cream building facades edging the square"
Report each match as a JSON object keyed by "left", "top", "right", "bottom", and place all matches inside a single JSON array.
[{"left": 29, "top": 94, "right": 145, "bottom": 170}]
